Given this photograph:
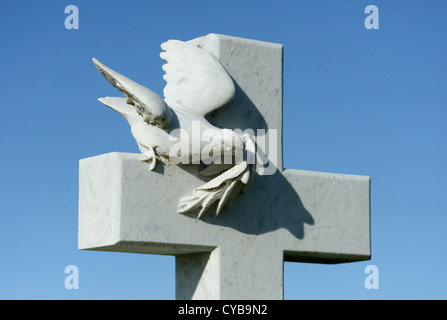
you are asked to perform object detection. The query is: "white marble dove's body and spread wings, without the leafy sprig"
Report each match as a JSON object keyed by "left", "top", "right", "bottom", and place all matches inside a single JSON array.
[{"left": 93, "top": 40, "right": 244, "bottom": 170}]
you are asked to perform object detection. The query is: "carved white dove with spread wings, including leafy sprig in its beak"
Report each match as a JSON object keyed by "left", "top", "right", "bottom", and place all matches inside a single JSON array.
[{"left": 93, "top": 40, "right": 254, "bottom": 218}]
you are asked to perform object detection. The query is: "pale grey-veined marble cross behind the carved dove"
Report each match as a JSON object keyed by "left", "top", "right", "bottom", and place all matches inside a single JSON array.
[{"left": 79, "top": 34, "right": 371, "bottom": 299}]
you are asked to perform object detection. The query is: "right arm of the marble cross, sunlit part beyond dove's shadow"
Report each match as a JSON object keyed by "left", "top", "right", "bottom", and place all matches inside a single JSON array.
[{"left": 283, "top": 169, "right": 371, "bottom": 263}]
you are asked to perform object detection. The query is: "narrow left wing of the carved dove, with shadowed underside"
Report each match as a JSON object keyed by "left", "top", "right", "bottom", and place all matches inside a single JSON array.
[{"left": 93, "top": 58, "right": 172, "bottom": 129}]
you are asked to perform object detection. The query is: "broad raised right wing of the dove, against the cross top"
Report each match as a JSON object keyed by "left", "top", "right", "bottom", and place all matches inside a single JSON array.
[{"left": 160, "top": 40, "right": 235, "bottom": 116}]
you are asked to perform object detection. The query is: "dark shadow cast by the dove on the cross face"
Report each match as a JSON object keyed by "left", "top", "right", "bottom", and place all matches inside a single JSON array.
[{"left": 183, "top": 82, "right": 314, "bottom": 239}]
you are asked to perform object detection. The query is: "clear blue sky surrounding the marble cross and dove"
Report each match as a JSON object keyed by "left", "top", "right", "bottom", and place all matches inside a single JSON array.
[{"left": 0, "top": 0, "right": 447, "bottom": 299}]
